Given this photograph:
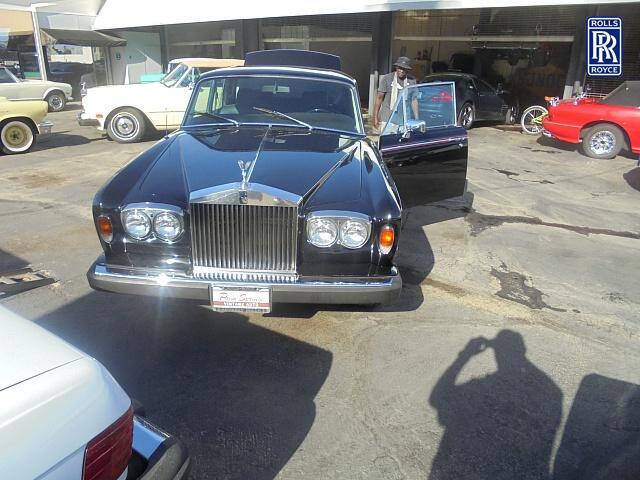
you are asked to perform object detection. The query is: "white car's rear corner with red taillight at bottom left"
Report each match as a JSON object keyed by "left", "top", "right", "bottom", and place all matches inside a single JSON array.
[{"left": 0, "top": 307, "right": 190, "bottom": 480}]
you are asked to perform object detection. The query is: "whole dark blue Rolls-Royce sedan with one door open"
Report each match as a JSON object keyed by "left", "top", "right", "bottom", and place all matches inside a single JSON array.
[{"left": 87, "top": 51, "right": 467, "bottom": 312}]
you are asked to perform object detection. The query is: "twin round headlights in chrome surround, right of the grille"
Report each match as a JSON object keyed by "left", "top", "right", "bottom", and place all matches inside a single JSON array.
[{"left": 307, "top": 210, "right": 371, "bottom": 249}]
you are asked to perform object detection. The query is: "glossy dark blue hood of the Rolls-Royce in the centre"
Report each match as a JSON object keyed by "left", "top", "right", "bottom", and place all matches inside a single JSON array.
[{"left": 127, "top": 126, "right": 362, "bottom": 205}]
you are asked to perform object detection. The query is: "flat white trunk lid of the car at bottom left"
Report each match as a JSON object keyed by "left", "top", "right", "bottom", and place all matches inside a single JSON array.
[{"left": 0, "top": 307, "right": 86, "bottom": 391}]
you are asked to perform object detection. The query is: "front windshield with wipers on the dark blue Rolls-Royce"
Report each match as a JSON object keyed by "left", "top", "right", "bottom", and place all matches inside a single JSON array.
[{"left": 184, "top": 76, "right": 363, "bottom": 134}]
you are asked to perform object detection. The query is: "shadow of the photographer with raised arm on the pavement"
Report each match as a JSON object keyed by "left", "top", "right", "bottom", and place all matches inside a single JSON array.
[{"left": 429, "top": 330, "right": 562, "bottom": 480}]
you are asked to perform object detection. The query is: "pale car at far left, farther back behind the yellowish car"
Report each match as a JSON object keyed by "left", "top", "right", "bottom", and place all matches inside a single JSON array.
[{"left": 0, "top": 67, "right": 73, "bottom": 112}]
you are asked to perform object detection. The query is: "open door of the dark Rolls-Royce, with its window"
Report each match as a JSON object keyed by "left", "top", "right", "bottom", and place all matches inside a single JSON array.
[{"left": 379, "top": 82, "right": 468, "bottom": 208}]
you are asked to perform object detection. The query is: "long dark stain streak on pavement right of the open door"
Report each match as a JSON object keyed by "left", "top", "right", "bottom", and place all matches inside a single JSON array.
[{"left": 464, "top": 208, "right": 640, "bottom": 240}]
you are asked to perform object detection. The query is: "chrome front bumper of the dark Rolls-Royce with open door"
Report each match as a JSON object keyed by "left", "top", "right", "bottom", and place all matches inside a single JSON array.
[{"left": 87, "top": 261, "right": 402, "bottom": 305}]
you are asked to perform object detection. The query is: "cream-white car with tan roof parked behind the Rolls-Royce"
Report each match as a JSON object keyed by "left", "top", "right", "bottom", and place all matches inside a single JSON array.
[{"left": 78, "top": 58, "right": 244, "bottom": 143}]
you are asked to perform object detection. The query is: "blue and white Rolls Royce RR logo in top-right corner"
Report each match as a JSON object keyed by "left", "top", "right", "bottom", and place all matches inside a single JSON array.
[{"left": 587, "top": 17, "right": 622, "bottom": 77}]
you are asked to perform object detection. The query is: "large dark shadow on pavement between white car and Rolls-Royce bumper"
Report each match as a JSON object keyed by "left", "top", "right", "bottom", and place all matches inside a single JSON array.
[{"left": 36, "top": 292, "right": 332, "bottom": 479}]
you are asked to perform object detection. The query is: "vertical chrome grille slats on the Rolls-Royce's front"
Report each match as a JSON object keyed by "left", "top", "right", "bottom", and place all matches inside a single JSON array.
[{"left": 190, "top": 203, "right": 298, "bottom": 281}]
